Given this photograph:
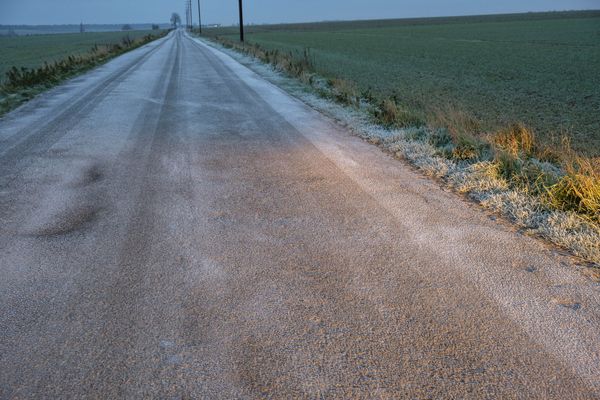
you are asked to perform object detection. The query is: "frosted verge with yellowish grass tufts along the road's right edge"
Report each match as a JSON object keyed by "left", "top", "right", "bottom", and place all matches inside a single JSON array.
[{"left": 203, "top": 35, "right": 600, "bottom": 264}]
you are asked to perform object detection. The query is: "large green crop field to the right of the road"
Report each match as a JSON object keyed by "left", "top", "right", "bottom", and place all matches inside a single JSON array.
[{"left": 208, "top": 11, "right": 600, "bottom": 156}]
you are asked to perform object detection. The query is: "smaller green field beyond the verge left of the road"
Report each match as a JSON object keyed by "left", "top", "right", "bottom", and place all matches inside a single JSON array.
[{"left": 0, "top": 31, "right": 153, "bottom": 79}]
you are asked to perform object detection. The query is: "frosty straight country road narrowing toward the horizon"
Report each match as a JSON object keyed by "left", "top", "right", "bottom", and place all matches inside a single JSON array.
[{"left": 0, "top": 31, "right": 600, "bottom": 399}]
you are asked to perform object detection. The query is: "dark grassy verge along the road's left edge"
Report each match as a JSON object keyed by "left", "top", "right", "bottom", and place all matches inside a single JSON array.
[{"left": 0, "top": 31, "right": 168, "bottom": 116}]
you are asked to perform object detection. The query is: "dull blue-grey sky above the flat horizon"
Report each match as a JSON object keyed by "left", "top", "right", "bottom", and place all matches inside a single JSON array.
[{"left": 0, "top": 0, "right": 600, "bottom": 25}]
